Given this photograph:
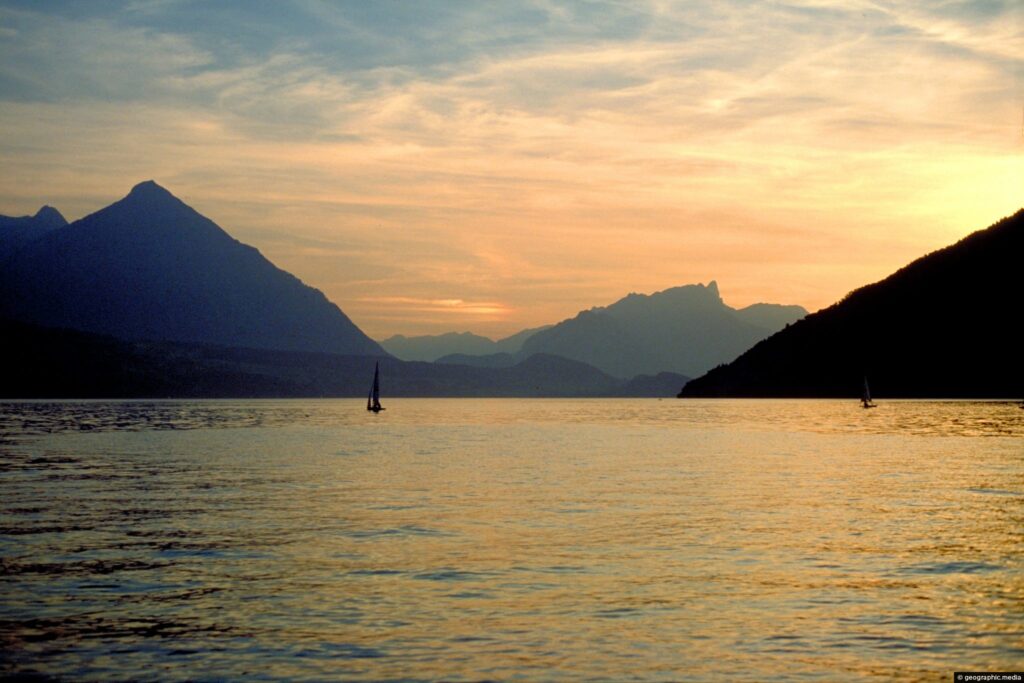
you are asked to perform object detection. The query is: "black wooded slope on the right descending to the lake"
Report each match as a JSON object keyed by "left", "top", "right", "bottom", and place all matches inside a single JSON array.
[{"left": 679, "top": 210, "right": 1024, "bottom": 398}]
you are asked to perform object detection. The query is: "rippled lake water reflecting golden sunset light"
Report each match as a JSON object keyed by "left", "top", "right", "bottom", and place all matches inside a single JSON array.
[{"left": 0, "top": 399, "right": 1024, "bottom": 681}]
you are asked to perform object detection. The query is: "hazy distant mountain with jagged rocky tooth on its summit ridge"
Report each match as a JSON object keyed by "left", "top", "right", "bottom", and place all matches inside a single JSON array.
[{"left": 519, "top": 281, "right": 807, "bottom": 378}]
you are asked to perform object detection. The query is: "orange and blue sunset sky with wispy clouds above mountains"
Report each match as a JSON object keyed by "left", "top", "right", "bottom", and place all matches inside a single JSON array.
[{"left": 0, "top": 0, "right": 1024, "bottom": 339}]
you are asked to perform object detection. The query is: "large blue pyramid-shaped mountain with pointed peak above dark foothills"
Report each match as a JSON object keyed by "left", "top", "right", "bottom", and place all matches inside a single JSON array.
[{"left": 0, "top": 180, "right": 385, "bottom": 355}]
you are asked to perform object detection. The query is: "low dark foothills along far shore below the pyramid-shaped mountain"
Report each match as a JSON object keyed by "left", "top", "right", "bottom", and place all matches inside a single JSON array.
[{"left": 0, "top": 321, "right": 687, "bottom": 404}]
